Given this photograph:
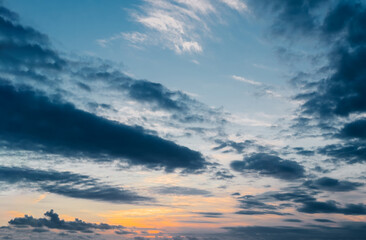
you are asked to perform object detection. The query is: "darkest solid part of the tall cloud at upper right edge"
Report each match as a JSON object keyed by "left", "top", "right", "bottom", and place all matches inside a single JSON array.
[{"left": 292, "top": 1, "right": 366, "bottom": 122}]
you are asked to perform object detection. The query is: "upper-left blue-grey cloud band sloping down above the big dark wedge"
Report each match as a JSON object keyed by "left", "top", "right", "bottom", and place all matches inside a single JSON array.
[{"left": 0, "top": 3, "right": 214, "bottom": 124}]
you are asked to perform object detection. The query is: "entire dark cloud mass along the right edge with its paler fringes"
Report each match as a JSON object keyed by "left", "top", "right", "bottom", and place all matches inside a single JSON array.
[{"left": 248, "top": 0, "right": 366, "bottom": 169}]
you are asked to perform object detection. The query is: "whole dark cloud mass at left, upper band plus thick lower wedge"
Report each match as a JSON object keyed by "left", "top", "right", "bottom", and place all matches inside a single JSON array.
[{"left": 0, "top": 4, "right": 213, "bottom": 172}]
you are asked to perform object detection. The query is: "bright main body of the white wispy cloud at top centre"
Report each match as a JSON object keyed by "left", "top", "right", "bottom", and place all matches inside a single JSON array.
[{"left": 134, "top": 0, "right": 210, "bottom": 54}]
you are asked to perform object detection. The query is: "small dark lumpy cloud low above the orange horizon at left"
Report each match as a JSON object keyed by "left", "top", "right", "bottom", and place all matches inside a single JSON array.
[{"left": 9, "top": 209, "right": 124, "bottom": 233}]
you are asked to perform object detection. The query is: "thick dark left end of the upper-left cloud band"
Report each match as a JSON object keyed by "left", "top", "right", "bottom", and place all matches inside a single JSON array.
[{"left": 0, "top": 6, "right": 67, "bottom": 84}]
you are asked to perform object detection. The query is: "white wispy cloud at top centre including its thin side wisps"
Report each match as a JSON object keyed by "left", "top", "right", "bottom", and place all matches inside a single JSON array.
[{"left": 117, "top": 0, "right": 247, "bottom": 54}]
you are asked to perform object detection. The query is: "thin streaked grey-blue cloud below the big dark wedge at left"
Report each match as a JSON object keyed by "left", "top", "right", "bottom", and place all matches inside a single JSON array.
[{"left": 0, "top": 166, "right": 152, "bottom": 203}]
